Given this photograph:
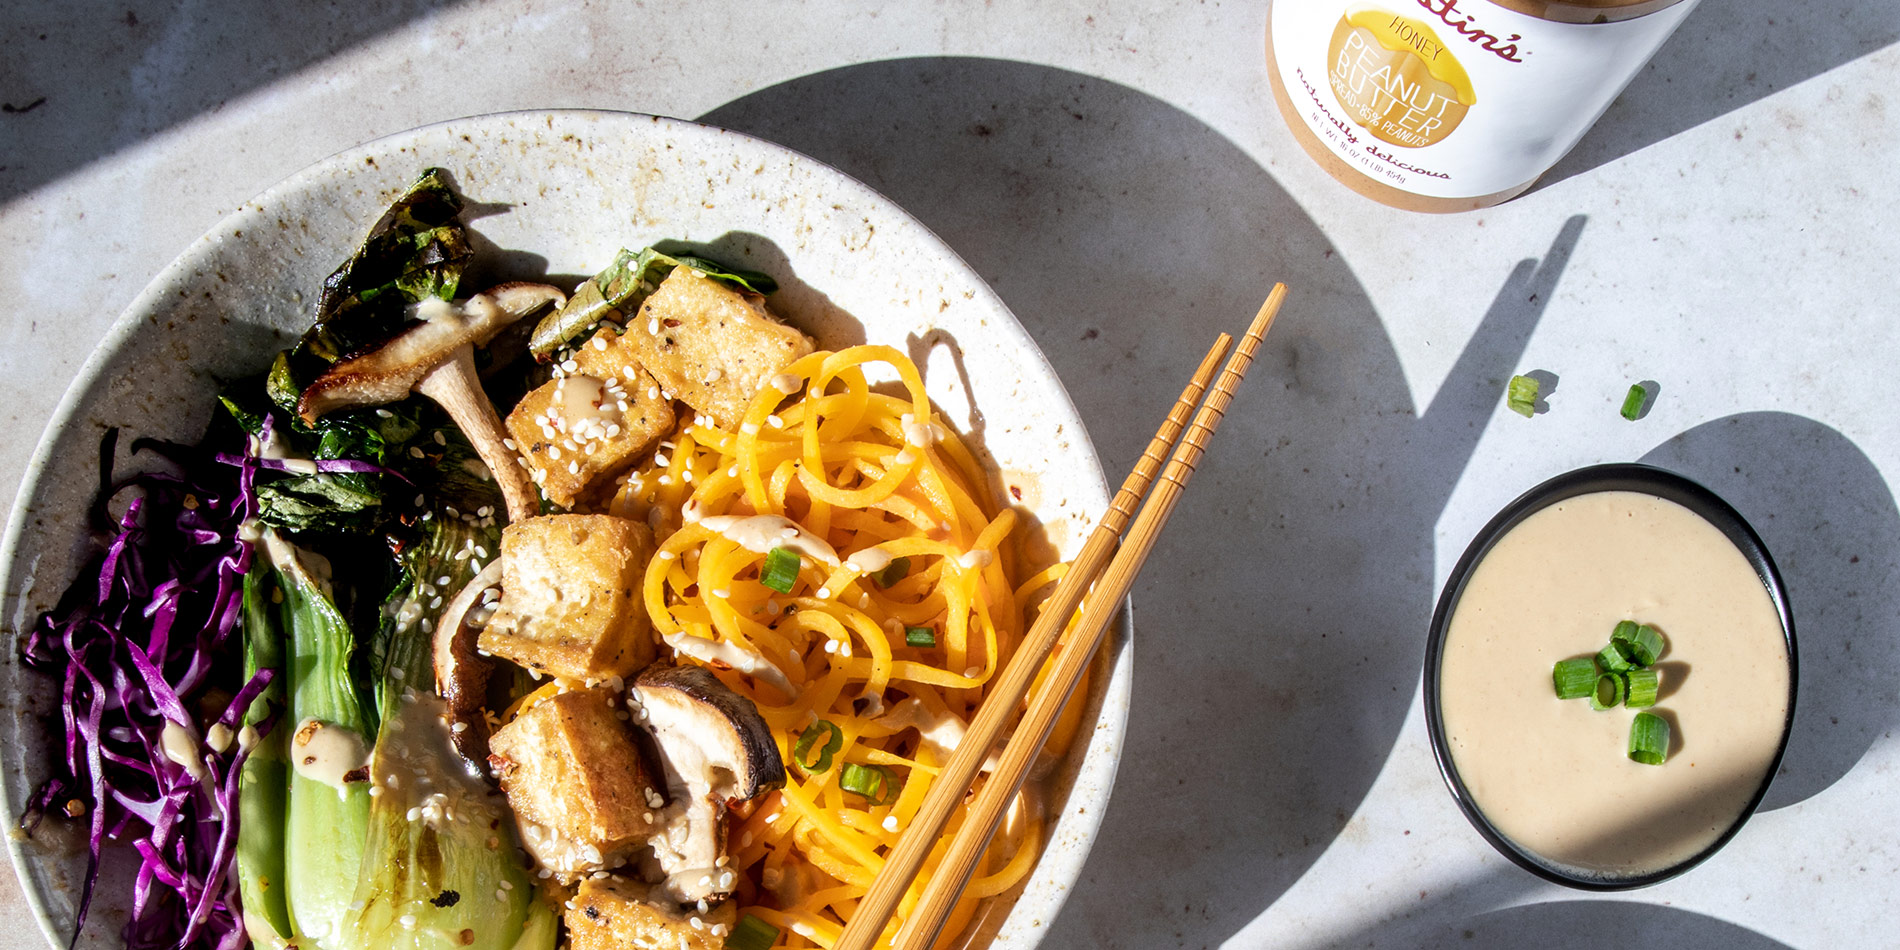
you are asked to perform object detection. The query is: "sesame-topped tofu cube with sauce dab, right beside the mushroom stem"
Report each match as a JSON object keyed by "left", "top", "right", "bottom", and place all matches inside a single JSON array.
[{"left": 507, "top": 351, "right": 675, "bottom": 507}]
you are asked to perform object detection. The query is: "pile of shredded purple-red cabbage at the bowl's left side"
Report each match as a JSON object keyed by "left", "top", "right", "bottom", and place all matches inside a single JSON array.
[{"left": 21, "top": 433, "right": 281, "bottom": 950}]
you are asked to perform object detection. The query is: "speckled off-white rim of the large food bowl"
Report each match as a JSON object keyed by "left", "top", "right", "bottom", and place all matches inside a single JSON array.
[{"left": 0, "top": 108, "right": 1134, "bottom": 948}]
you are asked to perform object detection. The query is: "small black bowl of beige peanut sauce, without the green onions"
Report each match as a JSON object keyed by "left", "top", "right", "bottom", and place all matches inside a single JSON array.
[{"left": 1425, "top": 466, "right": 1796, "bottom": 889}]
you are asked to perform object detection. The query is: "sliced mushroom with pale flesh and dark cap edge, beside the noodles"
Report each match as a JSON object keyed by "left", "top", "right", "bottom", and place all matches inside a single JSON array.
[{"left": 633, "top": 665, "right": 785, "bottom": 802}]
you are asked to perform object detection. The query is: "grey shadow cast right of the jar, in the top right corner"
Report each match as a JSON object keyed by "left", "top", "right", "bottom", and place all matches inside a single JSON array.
[{"left": 1537, "top": 0, "right": 1900, "bottom": 188}]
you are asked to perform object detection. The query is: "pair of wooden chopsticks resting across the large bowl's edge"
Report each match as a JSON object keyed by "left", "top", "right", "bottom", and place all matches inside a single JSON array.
[{"left": 832, "top": 283, "right": 1286, "bottom": 950}]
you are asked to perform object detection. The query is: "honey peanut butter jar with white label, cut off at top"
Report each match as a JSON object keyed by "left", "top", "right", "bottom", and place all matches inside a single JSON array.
[{"left": 1267, "top": 0, "right": 1699, "bottom": 213}]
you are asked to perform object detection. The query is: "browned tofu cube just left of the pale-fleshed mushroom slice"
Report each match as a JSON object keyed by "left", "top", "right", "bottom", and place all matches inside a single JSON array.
[{"left": 488, "top": 688, "right": 663, "bottom": 878}]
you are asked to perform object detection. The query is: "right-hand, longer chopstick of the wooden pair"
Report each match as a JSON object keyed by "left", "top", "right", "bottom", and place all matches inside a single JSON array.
[{"left": 895, "top": 285, "right": 1286, "bottom": 950}]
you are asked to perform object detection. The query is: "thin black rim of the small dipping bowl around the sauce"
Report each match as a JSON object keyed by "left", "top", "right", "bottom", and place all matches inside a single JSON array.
[{"left": 1425, "top": 464, "right": 1799, "bottom": 891}]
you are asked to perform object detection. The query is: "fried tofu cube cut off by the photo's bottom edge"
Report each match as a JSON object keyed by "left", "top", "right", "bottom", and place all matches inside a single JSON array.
[{"left": 566, "top": 876, "right": 739, "bottom": 950}]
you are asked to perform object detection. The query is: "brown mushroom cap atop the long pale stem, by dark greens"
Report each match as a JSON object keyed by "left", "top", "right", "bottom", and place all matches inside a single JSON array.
[{"left": 296, "top": 281, "right": 568, "bottom": 424}]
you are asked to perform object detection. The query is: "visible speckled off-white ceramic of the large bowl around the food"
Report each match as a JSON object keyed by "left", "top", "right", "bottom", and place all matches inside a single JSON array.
[{"left": 0, "top": 112, "right": 1131, "bottom": 948}]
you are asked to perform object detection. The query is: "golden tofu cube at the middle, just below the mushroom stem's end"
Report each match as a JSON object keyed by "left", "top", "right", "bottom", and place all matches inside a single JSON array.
[{"left": 475, "top": 515, "right": 657, "bottom": 680}]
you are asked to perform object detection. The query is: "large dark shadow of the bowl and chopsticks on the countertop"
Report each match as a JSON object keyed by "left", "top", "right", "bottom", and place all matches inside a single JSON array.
[{"left": 701, "top": 59, "right": 1585, "bottom": 948}]
